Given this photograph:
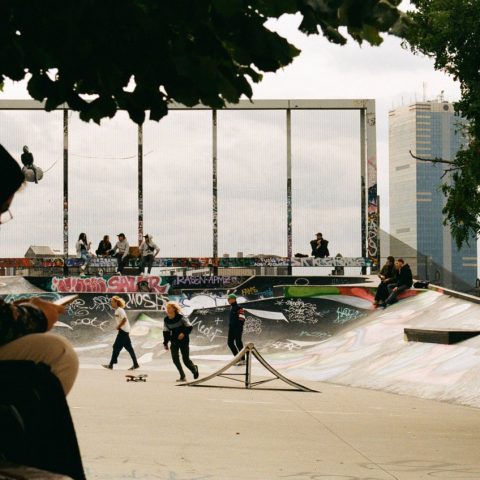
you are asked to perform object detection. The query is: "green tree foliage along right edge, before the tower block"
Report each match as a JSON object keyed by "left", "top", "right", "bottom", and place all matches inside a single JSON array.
[{"left": 406, "top": 0, "right": 480, "bottom": 247}]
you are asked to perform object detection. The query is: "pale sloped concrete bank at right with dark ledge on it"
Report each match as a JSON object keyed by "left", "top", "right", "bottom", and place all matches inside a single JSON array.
[{"left": 269, "top": 291, "right": 480, "bottom": 407}]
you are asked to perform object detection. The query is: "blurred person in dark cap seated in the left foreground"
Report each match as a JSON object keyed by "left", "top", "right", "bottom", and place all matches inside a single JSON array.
[{"left": 0, "top": 144, "right": 85, "bottom": 480}]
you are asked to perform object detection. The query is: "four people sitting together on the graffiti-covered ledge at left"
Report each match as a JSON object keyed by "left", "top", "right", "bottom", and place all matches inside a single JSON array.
[{"left": 75, "top": 232, "right": 160, "bottom": 274}]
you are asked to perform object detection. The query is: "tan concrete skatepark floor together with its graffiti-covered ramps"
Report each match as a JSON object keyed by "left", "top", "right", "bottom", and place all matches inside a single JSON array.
[{"left": 1, "top": 277, "right": 480, "bottom": 480}]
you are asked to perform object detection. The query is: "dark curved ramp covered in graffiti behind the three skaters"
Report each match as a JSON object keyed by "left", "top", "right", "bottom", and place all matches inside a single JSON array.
[{"left": 57, "top": 287, "right": 373, "bottom": 362}]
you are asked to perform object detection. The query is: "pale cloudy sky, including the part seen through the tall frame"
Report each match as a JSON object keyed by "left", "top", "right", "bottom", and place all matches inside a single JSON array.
[{"left": 0, "top": 2, "right": 460, "bottom": 257}]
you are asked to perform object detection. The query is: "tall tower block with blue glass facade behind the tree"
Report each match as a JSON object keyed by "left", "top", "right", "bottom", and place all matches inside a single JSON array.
[{"left": 389, "top": 101, "right": 477, "bottom": 290}]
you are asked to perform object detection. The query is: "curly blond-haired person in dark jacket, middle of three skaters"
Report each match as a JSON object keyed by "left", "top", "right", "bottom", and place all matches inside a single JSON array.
[{"left": 163, "top": 302, "right": 199, "bottom": 382}]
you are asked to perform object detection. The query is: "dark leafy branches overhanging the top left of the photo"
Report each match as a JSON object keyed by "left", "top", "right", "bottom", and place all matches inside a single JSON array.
[{"left": 0, "top": 0, "right": 407, "bottom": 124}]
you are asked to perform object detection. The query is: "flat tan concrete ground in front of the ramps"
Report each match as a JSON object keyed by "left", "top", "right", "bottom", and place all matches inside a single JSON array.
[{"left": 69, "top": 364, "right": 480, "bottom": 480}]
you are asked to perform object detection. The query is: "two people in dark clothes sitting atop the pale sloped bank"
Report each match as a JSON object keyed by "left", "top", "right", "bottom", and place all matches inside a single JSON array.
[{"left": 374, "top": 256, "right": 413, "bottom": 308}]
